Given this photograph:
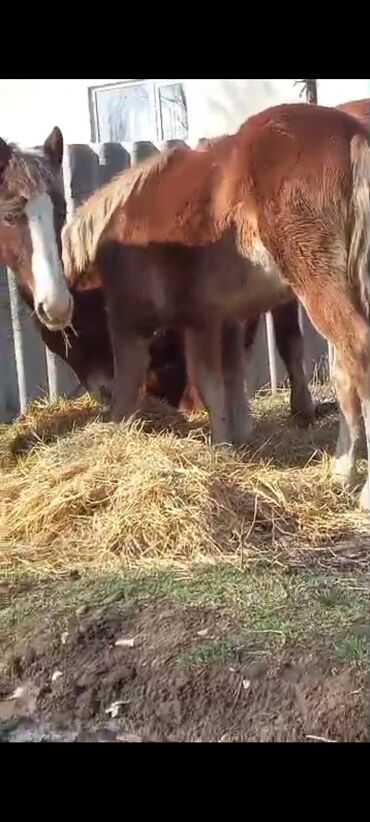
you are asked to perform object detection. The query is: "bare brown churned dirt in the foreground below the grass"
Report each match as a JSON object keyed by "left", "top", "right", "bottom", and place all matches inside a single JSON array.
[{"left": 0, "top": 597, "right": 369, "bottom": 742}]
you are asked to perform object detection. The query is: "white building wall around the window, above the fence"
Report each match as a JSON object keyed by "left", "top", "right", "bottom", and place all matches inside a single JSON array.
[{"left": 0, "top": 79, "right": 370, "bottom": 146}]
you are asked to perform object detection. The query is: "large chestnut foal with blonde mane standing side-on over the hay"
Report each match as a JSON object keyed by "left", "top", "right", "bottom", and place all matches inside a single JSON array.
[{"left": 63, "top": 104, "right": 370, "bottom": 509}]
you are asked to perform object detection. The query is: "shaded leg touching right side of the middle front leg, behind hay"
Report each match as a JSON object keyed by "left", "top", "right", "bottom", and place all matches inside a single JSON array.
[{"left": 222, "top": 322, "right": 253, "bottom": 445}]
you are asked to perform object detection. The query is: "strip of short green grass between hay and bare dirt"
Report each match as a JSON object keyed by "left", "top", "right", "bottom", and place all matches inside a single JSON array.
[{"left": 0, "top": 564, "right": 368, "bottom": 676}]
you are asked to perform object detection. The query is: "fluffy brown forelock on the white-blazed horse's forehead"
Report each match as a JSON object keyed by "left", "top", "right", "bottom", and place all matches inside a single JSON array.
[{"left": 0, "top": 143, "right": 54, "bottom": 223}]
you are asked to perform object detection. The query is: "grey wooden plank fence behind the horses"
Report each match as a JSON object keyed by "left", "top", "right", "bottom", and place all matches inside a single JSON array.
[{"left": 0, "top": 141, "right": 328, "bottom": 423}]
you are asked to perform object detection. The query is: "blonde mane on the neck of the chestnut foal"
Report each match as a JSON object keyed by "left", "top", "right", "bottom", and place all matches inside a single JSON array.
[{"left": 62, "top": 148, "right": 181, "bottom": 283}]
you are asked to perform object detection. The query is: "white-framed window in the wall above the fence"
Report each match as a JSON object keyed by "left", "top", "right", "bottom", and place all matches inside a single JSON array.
[{"left": 89, "top": 80, "right": 188, "bottom": 143}]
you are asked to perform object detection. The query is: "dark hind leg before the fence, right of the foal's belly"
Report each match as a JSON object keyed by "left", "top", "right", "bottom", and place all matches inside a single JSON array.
[{"left": 272, "top": 300, "right": 315, "bottom": 428}]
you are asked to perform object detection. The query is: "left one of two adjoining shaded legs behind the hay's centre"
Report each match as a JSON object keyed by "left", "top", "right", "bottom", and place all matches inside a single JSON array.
[{"left": 185, "top": 323, "right": 231, "bottom": 445}]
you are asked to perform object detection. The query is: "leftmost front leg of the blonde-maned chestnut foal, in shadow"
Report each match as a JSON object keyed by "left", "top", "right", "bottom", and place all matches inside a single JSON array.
[{"left": 110, "top": 331, "right": 150, "bottom": 422}]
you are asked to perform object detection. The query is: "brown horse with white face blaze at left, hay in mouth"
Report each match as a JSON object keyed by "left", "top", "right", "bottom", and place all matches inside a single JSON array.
[{"left": 0, "top": 128, "right": 186, "bottom": 406}]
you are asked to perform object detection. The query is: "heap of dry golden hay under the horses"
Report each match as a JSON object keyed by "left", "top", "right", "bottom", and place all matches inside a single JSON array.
[{"left": 0, "top": 394, "right": 369, "bottom": 575}]
